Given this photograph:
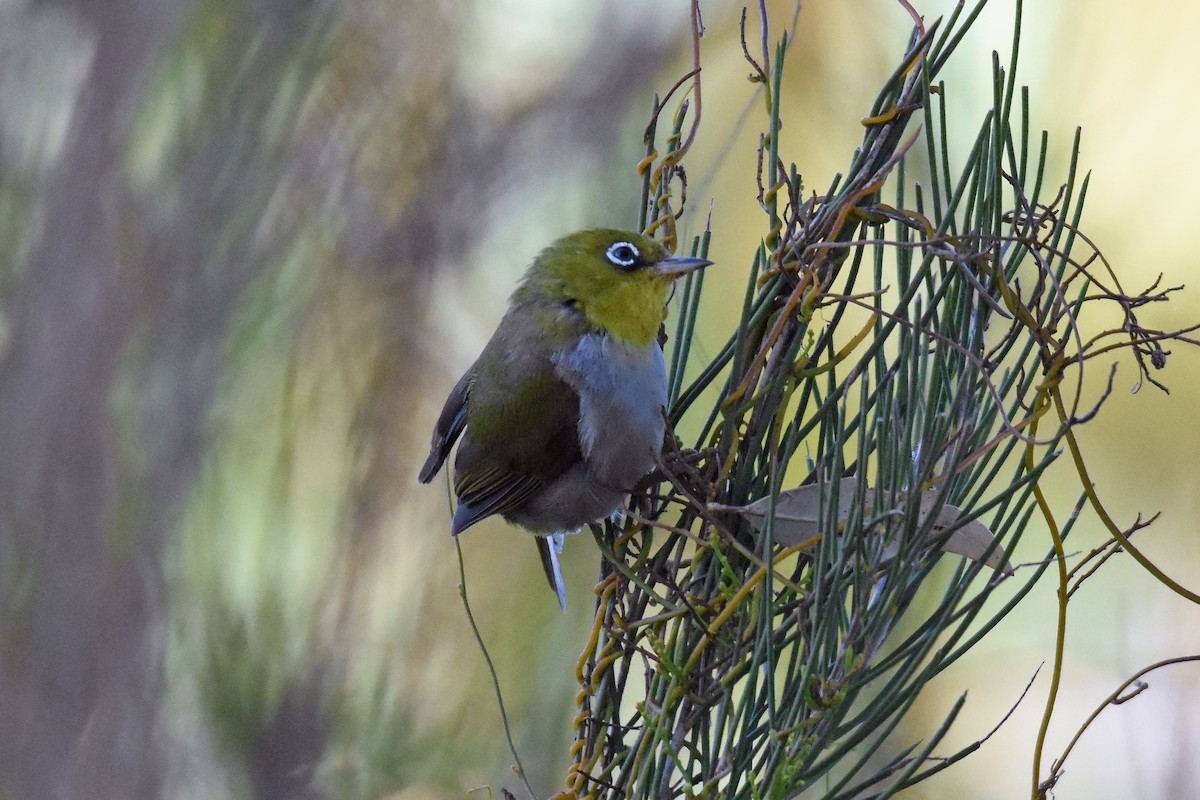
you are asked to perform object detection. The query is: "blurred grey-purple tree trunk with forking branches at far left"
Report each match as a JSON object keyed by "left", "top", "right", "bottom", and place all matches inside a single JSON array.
[{"left": 0, "top": 0, "right": 326, "bottom": 799}]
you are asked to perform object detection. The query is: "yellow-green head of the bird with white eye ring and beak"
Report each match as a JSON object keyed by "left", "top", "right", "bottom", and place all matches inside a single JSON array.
[{"left": 521, "top": 228, "right": 712, "bottom": 347}]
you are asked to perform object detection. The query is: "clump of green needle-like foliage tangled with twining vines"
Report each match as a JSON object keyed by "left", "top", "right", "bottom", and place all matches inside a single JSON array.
[{"left": 568, "top": 2, "right": 1200, "bottom": 799}]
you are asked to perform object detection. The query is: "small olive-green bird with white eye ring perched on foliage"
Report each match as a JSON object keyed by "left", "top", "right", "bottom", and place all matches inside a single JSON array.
[{"left": 419, "top": 229, "right": 712, "bottom": 608}]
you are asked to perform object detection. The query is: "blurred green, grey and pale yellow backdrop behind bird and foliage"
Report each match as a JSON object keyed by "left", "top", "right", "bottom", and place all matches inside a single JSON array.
[{"left": 0, "top": 0, "right": 1200, "bottom": 800}]
